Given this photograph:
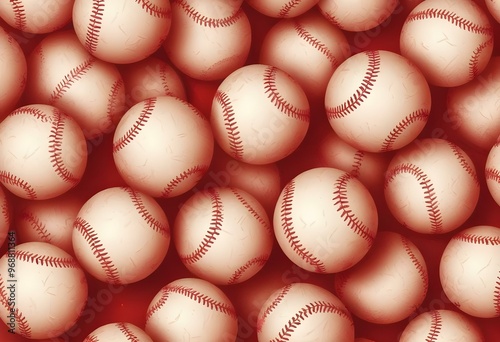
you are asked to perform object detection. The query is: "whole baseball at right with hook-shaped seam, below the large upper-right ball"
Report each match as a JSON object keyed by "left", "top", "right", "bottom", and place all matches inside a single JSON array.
[{"left": 384, "top": 138, "right": 480, "bottom": 234}]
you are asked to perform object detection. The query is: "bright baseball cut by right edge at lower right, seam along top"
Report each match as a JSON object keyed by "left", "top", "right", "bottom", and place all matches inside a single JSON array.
[{"left": 439, "top": 225, "right": 500, "bottom": 318}]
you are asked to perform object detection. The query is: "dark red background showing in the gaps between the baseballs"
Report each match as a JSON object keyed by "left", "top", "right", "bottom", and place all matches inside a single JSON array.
[{"left": 0, "top": 0, "right": 500, "bottom": 342}]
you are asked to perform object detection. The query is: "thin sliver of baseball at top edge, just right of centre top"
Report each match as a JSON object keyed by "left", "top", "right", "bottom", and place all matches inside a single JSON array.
[{"left": 246, "top": 0, "right": 318, "bottom": 18}]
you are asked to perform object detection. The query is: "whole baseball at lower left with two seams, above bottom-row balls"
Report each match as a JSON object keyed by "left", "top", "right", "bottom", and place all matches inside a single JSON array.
[{"left": 72, "top": 187, "right": 170, "bottom": 284}]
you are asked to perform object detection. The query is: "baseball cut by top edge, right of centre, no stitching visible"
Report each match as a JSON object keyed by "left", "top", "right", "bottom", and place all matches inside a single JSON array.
[{"left": 318, "top": 0, "right": 398, "bottom": 32}]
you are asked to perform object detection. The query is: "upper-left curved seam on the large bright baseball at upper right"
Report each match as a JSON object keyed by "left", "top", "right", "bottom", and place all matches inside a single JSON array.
[{"left": 326, "top": 50, "right": 380, "bottom": 120}]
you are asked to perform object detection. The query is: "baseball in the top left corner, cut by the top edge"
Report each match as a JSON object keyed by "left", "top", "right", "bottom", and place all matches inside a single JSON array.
[{"left": 0, "top": 0, "right": 74, "bottom": 34}]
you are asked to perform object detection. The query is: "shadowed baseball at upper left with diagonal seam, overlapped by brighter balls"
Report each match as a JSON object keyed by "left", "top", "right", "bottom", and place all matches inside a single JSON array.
[{"left": 27, "top": 30, "right": 125, "bottom": 139}]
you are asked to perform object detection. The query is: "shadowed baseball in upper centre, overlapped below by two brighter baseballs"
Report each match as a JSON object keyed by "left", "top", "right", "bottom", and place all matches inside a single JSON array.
[{"left": 259, "top": 12, "right": 351, "bottom": 102}]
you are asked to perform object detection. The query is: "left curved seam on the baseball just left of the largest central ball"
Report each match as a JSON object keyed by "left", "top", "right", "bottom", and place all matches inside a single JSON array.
[{"left": 180, "top": 188, "right": 224, "bottom": 264}]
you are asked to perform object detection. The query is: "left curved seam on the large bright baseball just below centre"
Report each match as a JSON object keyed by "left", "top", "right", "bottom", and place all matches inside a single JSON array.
[{"left": 280, "top": 179, "right": 326, "bottom": 273}]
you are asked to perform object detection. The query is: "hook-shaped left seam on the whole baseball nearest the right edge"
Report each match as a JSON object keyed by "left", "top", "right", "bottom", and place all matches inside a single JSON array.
[{"left": 384, "top": 163, "right": 443, "bottom": 233}]
